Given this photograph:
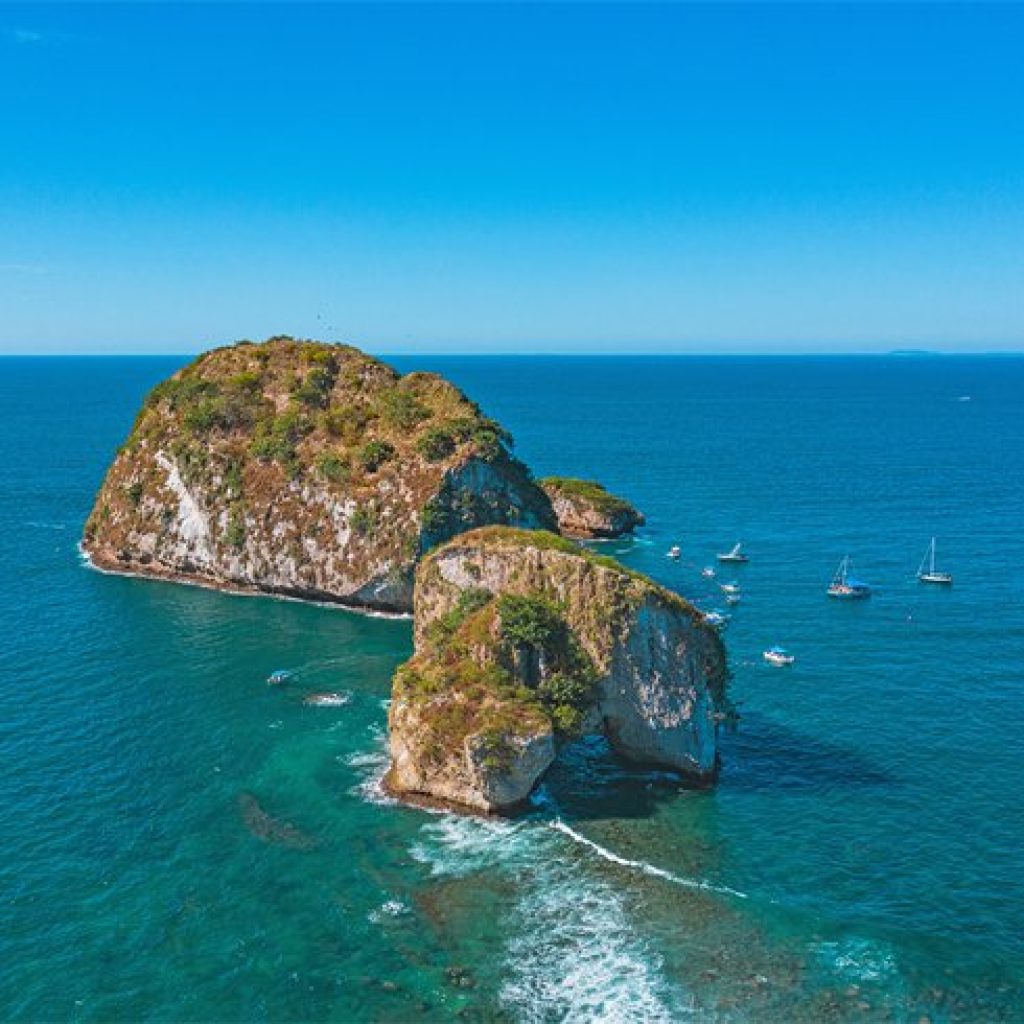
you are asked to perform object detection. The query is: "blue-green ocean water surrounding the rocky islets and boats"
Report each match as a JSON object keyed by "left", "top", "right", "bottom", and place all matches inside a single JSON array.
[{"left": 0, "top": 357, "right": 1024, "bottom": 1022}]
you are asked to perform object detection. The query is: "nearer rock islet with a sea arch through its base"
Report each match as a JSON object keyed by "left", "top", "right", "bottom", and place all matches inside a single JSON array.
[{"left": 387, "top": 527, "right": 726, "bottom": 811}]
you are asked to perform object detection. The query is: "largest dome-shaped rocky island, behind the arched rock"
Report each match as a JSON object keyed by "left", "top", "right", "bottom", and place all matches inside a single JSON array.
[{"left": 83, "top": 338, "right": 555, "bottom": 611}]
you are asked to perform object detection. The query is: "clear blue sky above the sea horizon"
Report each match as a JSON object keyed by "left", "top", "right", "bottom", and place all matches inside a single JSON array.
[{"left": 0, "top": 3, "right": 1024, "bottom": 352}]
